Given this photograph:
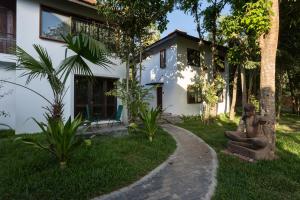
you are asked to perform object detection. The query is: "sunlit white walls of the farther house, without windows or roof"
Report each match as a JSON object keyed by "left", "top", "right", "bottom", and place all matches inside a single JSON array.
[{"left": 142, "top": 37, "right": 229, "bottom": 115}]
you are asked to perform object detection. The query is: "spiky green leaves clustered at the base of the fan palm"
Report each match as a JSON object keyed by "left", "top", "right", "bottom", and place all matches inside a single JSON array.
[{"left": 17, "top": 115, "right": 84, "bottom": 168}]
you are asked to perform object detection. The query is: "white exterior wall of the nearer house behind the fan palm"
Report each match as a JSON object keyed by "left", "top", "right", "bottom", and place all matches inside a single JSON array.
[{"left": 0, "top": 0, "right": 125, "bottom": 133}]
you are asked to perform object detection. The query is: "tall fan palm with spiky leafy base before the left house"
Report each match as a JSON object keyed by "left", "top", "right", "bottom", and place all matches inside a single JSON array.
[{"left": 6, "top": 33, "right": 113, "bottom": 168}]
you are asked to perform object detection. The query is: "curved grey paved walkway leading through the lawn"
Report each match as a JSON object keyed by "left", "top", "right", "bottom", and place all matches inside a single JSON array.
[{"left": 96, "top": 124, "right": 217, "bottom": 200}]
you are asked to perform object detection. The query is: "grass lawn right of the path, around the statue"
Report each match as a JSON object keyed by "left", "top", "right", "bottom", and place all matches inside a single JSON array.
[{"left": 180, "top": 115, "right": 300, "bottom": 200}]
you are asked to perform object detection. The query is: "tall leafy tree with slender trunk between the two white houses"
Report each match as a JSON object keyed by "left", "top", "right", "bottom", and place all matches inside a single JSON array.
[{"left": 97, "top": 0, "right": 174, "bottom": 121}]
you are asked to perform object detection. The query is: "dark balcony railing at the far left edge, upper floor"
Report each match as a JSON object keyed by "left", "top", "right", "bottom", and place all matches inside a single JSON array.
[{"left": 0, "top": 32, "right": 16, "bottom": 54}]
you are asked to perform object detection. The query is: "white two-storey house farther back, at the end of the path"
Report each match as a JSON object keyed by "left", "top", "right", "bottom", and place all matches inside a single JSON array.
[{"left": 142, "top": 30, "right": 229, "bottom": 115}]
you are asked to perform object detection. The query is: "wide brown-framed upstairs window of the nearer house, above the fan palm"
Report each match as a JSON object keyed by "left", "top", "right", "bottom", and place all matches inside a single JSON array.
[{"left": 40, "top": 7, "right": 115, "bottom": 48}]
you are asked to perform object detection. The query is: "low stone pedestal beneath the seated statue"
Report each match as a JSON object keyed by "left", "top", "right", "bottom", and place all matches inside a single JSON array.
[{"left": 227, "top": 141, "right": 273, "bottom": 160}]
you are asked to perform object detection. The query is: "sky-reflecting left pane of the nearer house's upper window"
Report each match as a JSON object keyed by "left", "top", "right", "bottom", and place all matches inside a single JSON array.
[{"left": 41, "top": 9, "right": 71, "bottom": 41}]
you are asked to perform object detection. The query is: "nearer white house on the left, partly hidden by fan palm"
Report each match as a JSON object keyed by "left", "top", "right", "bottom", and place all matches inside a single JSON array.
[{"left": 0, "top": 0, "right": 126, "bottom": 133}]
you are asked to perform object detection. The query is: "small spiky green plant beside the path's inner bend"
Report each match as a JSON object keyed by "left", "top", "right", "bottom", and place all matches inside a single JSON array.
[{"left": 139, "top": 107, "right": 161, "bottom": 142}]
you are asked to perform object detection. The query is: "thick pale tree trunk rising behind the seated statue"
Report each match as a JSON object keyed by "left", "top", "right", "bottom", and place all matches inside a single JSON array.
[{"left": 260, "top": 0, "right": 279, "bottom": 159}]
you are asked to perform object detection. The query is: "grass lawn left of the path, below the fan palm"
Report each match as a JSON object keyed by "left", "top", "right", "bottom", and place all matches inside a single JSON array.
[{"left": 0, "top": 130, "right": 176, "bottom": 200}]
